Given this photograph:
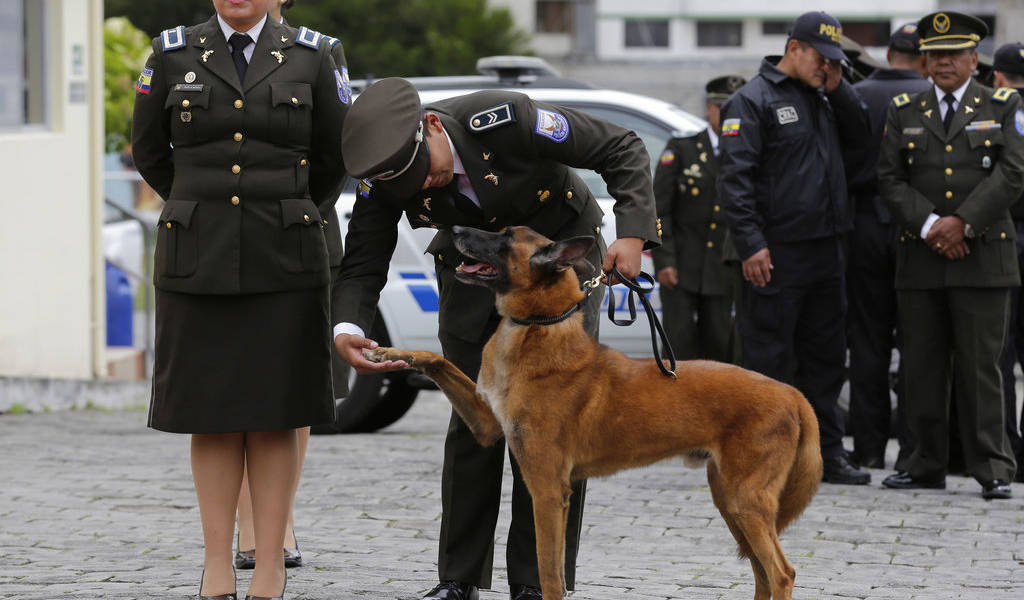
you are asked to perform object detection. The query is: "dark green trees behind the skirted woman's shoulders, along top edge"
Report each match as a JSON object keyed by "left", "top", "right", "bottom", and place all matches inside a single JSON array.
[{"left": 104, "top": 0, "right": 528, "bottom": 78}]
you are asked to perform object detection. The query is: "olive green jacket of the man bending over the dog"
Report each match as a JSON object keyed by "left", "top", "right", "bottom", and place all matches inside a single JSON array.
[{"left": 341, "top": 91, "right": 658, "bottom": 341}]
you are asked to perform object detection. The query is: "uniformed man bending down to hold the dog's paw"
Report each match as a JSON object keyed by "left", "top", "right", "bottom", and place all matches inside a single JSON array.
[{"left": 335, "top": 79, "right": 658, "bottom": 600}]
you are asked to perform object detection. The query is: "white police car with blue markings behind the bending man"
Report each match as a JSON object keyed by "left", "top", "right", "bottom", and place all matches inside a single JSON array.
[{"left": 323, "top": 56, "right": 707, "bottom": 433}]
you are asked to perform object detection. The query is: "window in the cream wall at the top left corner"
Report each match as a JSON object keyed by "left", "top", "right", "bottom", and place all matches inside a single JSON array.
[{"left": 0, "top": 0, "right": 47, "bottom": 129}]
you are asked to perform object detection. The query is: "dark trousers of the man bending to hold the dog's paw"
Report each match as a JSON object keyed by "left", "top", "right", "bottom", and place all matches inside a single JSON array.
[{"left": 437, "top": 264, "right": 604, "bottom": 590}]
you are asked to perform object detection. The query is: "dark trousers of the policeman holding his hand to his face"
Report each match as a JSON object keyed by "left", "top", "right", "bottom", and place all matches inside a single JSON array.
[{"left": 739, "top": 235, "right": 846, "bottom": 459}]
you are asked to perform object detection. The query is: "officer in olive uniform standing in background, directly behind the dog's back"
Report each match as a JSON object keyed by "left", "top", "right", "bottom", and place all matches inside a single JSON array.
[{"left": 651, "top": 75, "right": 746, "bottom": 362}]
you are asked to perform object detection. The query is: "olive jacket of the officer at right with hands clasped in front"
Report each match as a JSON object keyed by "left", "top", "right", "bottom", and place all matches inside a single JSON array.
[{"left": 879, "top": 80, "right": 1024, "bottom": 290}]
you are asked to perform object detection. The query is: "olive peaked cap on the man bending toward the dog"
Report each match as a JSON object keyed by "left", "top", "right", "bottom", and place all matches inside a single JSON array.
[{"left": 341, "top": 77, "right": 430, "bottom": 200}]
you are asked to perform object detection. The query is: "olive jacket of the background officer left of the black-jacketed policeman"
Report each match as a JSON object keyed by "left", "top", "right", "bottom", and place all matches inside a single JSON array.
[{"left": 650, "top": 130, "right": 734, "bottom": 296}]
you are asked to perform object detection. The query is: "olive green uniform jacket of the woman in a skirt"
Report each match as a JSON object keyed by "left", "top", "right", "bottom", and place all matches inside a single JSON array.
[{"left": 132, "top": 16, "right": 350, "bottom": 294}]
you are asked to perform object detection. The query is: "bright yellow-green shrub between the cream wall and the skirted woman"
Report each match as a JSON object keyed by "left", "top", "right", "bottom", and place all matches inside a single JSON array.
[{"left": 103, "top": 16, "right": 150, "bottom": 152}]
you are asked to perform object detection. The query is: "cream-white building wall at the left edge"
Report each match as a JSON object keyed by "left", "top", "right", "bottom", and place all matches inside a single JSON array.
[{"left": 0, "top": 0, "right": 103, "bottom": 379}]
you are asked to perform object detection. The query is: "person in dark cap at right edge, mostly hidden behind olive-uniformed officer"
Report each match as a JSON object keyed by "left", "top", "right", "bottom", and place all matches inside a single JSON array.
[{"left": 992, "top": 42, "right": 1024, "bottom": 481}]
